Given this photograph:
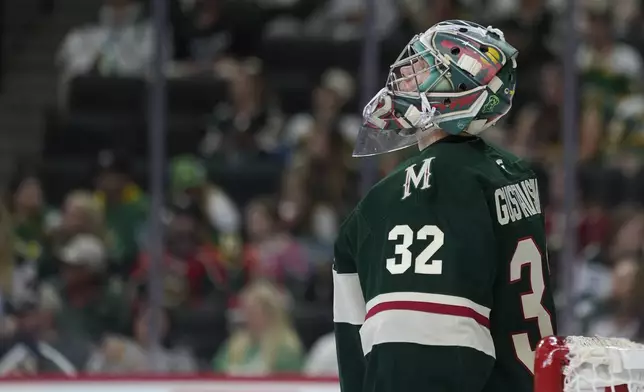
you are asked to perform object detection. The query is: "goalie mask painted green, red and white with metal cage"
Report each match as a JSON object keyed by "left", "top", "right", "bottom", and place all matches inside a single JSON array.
[{"left": 353, "top": 21, "right": 518, "bottom": 157}]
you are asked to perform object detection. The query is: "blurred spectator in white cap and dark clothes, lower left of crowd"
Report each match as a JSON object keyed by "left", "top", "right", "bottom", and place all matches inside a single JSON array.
[{"left": 40, "top": 234, "right": 131, "bottom": 342}]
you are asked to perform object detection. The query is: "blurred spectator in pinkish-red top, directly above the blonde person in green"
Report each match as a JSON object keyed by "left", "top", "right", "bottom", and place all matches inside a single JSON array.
[{"left": 245, "top": 197, "right": 309, "bottom": 295}]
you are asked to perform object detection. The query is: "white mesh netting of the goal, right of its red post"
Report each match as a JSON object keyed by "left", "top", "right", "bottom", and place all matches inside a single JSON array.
[{"left": 564, "top": 336, "right": 644, "bottom": 392}]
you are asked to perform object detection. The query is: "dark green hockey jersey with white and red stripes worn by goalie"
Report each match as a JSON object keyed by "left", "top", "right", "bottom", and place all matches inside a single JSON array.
[{"left": 334, "top": 136, "right": 555, "bottom": 392}]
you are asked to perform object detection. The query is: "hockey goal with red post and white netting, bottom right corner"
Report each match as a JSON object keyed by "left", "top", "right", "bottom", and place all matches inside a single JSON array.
[{"left": 535, "top": 336, "right": 644, "bottom": 392}]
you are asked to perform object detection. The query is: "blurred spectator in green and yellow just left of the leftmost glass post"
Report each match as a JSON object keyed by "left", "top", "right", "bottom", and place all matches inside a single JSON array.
[{"left": 95, "top": 150, "right": 148, "bottom": 276}]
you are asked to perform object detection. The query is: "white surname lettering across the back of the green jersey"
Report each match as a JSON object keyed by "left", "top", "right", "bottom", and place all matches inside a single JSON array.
[{"left": 494, "top": 178, "right": 541, "bottom": 225}]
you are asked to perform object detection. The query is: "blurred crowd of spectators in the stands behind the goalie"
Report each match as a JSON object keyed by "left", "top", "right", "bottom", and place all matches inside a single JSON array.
[{"left": 0, "top": 0, "right": 644, "bottom": 376}]
